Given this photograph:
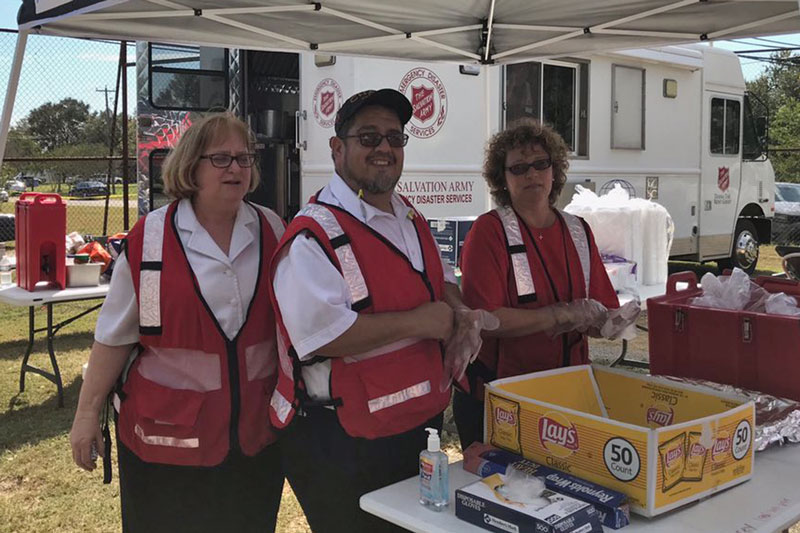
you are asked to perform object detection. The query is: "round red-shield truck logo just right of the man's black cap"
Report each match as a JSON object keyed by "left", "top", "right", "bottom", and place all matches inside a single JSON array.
[{"left": 397, "top": 67, "right": 448, "bottom": 139}]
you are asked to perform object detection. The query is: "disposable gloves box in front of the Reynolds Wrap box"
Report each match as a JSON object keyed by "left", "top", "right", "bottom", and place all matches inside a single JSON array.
[{"left": 456, "top": 474, "right": 603, "bottom": 533}]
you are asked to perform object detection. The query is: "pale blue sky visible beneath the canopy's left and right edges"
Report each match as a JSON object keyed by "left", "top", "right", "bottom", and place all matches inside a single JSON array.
[{"left": 0, "top": 0, "right": 800, "bottom": 122}]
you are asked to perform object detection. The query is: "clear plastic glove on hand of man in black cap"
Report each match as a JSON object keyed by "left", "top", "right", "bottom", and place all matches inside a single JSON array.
[{"left": 439, "top": 307, "right": 500, "bottom": 392}]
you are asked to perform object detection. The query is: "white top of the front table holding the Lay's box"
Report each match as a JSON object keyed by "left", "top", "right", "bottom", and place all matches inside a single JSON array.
[{"left": 360, "top": 444, "right": 800, "bottom": 533}]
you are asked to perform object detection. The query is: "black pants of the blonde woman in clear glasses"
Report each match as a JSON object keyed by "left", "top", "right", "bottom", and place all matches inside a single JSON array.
[{"left": 117, "top": 439, "right": 283, "bottom": 533}]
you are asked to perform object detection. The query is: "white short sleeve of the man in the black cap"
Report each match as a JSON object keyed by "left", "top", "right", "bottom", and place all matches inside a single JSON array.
[{"left": 272, "top": 235, "right": 358, "bottom": 360}]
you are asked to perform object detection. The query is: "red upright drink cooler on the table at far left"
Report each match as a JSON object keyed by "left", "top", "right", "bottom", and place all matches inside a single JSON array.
[{"left": 15, "top": 193, "right": 67, "bottom": 291}]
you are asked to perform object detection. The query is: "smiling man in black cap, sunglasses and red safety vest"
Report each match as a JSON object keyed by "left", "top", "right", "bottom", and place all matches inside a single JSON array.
[{"left": 271, "top": 89, "right": 462, "bottom": 532}]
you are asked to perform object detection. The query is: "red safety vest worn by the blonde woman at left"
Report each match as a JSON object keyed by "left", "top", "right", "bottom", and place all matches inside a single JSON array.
[{"left": 118, "top": 202, "right": 277, "bottom": 466}]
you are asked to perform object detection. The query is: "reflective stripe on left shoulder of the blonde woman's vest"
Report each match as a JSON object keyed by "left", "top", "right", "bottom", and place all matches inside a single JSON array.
[{"left": 139, "top": 208, "right": 167, "bottom": 335}]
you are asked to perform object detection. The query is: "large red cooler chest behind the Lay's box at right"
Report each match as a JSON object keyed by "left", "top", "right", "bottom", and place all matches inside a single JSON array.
[{"left": 647, "top": 272, "right": 800, "bottom": 400}]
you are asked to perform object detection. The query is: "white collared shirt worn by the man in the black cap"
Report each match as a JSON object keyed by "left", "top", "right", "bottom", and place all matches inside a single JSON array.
[{"left": 273, "top": 174, "right": 456, "bottom": 399}]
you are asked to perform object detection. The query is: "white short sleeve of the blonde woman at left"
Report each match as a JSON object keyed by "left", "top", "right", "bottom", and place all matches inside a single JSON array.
[{"left": 94, "top": 253, "right": 139, "bottom": 346}]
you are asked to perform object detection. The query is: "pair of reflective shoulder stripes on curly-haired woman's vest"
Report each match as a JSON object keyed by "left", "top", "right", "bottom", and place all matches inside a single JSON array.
[{"left": 495, "top": 207, "right": 592, "bottom": 296}]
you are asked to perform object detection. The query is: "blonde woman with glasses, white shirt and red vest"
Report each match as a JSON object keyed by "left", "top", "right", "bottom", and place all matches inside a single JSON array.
[{"left": 70, "top": 113, "right": 284, "bottom": 533}]
